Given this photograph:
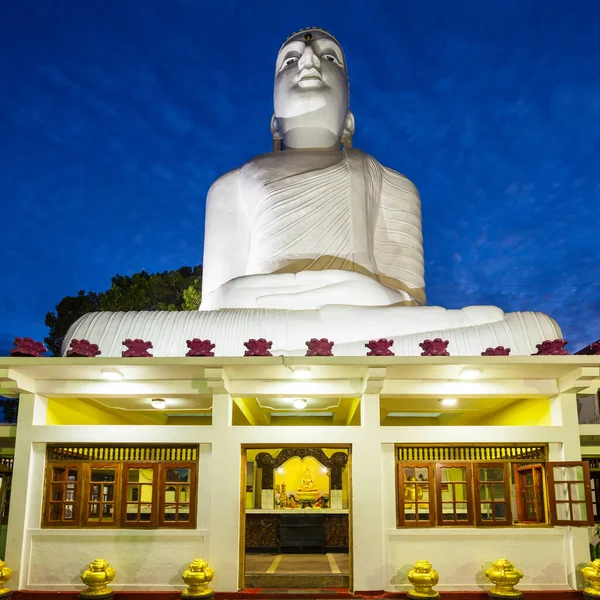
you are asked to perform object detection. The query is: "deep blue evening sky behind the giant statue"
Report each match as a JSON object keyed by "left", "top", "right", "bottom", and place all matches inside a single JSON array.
[{"left": 0, "top": 0, "right": 600, "bottom": 352}]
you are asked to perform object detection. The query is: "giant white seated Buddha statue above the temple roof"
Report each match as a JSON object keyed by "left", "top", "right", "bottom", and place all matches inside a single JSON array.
[{"left": 63, "top": 28, "right": 561, "bottom": 356}]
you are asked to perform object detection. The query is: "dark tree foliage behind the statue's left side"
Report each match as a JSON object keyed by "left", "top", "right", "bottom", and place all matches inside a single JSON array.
[{"left": 45, "top": 266, "right": 202, "bottom": 356}]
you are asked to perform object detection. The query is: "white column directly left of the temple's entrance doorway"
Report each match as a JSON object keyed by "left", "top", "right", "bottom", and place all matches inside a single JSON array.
[{"left": 206, "top": 393, "right": 241, "bottom": 592}]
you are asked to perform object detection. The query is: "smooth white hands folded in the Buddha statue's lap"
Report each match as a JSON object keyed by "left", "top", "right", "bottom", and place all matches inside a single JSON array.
[{"left": 202, "top": 270, "right": 413, "bottom": 310}]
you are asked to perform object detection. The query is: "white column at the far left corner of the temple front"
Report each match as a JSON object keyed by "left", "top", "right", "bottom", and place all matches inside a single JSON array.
[{"left": 6, "top": 394, "right": 47, "bottom": 589}]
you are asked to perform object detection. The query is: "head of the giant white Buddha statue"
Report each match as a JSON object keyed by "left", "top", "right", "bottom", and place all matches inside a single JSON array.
[{"left": 271, "top": 28, "right": 354, "bottom": 148}]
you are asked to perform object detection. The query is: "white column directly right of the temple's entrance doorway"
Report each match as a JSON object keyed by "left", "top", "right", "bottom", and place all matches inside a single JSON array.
[{"left": 351, "top": 393, "right": 384, "bottom": 591}]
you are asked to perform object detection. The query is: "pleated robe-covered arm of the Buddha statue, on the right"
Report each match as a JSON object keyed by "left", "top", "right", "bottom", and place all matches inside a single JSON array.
[{"left": 374, "top": 167, "right": 425, "bottom": 304}]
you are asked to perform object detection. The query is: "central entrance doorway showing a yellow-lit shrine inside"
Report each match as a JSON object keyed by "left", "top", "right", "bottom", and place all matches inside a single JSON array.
[{"left": 240, "top": 444, "right": 352, "bottom": 589}]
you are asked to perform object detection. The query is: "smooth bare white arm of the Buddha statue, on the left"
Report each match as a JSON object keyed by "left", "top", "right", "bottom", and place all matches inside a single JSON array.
[{"left": 202, "top": 169, "right": 250, "bottom": 301}]
